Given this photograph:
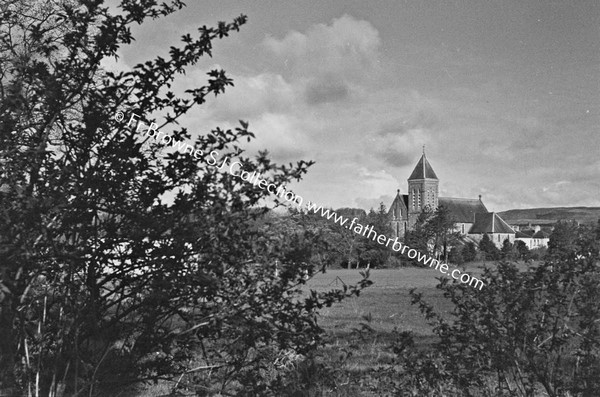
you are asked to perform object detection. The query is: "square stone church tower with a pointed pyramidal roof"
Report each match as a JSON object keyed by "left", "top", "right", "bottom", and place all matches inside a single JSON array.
[{"left": 408, "top": 146, "right": 439, "bottom": 228}]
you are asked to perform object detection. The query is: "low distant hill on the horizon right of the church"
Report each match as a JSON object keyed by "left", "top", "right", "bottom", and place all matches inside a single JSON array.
[{"left": 499, "top": 207, "right": 600, "bottom": 224}]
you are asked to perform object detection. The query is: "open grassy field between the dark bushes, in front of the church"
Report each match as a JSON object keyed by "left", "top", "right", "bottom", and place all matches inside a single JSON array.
[{"left": 138, "top": 263, "right": 527, "bottom": 396}]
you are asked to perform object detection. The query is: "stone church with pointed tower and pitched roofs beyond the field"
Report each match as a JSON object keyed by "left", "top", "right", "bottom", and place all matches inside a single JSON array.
[{"left": 388, "top": 148, "right": 515, "bottom": 247}]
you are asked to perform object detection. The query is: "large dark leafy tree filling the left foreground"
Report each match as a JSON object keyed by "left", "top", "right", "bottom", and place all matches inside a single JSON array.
[{"left": 0, "top": 0, "right": 368, "bottom": 396}]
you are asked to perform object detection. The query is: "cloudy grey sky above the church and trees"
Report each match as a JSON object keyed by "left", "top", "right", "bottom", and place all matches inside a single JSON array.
[{"left": 107, "top": 0, "right": 600, "bottom": 211}]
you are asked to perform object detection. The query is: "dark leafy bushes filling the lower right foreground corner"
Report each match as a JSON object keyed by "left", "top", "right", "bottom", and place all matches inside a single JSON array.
[{"left": 396, "top": 223, "right": 600, "bottom": 397}]
